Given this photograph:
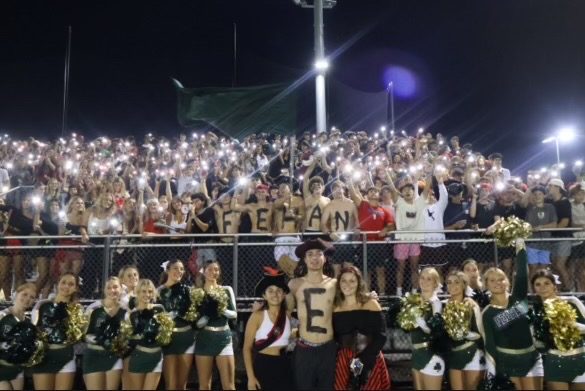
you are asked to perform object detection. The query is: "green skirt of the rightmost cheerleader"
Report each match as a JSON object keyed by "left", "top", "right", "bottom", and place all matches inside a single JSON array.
[{"left": 542, "top": 348, "right": 585, "bottom": 383}]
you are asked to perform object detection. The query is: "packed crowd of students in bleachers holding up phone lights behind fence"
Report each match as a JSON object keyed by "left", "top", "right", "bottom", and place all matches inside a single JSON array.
[{"left": 0, "top": 129, "right": 585, "bottom": 299}]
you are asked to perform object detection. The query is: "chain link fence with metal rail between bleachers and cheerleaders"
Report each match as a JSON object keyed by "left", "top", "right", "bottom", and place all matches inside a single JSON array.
[{"left": 0, "top": 231, "right": 585, "bottom": 299}]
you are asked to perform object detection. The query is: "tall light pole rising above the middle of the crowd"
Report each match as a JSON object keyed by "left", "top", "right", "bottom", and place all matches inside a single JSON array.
[{"left": 293, "top": 0, "right": 337, "bottom": 133}]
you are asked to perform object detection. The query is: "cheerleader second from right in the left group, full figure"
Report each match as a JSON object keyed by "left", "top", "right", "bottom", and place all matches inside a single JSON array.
[{"left": 158, "top": 259, "right": 195, "bottom": 390}]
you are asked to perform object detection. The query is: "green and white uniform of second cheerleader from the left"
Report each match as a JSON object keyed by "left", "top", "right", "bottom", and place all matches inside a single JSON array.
[{"left": 32, "top": 300, "right": 77, "bottom": 374}]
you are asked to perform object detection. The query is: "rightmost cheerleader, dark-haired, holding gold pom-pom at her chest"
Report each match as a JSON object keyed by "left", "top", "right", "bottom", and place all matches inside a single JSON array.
[{"left": 531, "top": 270, "right": 585, "bottom": 390}]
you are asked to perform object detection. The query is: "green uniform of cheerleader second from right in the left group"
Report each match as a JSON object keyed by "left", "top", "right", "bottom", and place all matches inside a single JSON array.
[{"left": 158, "top": 283, "right": 195, "bottom": 356}]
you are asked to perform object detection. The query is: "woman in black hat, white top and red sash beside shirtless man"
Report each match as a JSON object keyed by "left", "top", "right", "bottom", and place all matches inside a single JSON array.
[{"left": 243, "top": 268, "right": 293, "bottom": 390}]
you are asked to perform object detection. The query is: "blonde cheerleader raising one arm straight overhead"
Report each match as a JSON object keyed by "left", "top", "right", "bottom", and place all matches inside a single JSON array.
[{"left": 482, "top": 238, "right": 543, "bottom": 390}]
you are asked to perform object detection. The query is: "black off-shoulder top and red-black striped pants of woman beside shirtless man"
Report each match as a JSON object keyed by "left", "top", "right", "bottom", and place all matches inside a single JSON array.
[{"left": 333, "top": 310, "right": 390, "bottom": 390}]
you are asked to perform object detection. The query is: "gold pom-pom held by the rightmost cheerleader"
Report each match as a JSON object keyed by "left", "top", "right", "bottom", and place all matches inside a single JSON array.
[{"left": 544, "top": 298, "right": 583, "bottom": 352}]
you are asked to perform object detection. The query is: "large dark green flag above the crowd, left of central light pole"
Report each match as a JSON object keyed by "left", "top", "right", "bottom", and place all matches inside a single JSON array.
[{"left": 173, "top": 79, "right": 297, "bottom": 138}]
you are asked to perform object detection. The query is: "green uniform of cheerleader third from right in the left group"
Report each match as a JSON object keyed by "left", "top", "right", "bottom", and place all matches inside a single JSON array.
[{"left": 126, "top": 304, "right": 165, "bottom": 373}]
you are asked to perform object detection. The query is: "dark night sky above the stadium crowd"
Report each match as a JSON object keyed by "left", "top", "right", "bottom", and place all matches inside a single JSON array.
[{"left": 0, "top": 0, "right": 585, "bottom": 171}]
